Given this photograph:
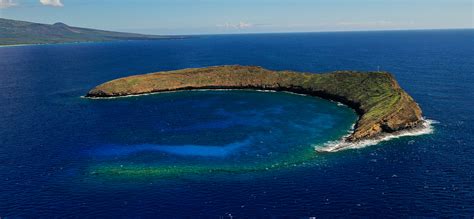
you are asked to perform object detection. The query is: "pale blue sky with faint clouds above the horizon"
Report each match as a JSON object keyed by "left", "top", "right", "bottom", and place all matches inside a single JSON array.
[{"left": 0, "top": 0, "right": 474, "bottom": 34}]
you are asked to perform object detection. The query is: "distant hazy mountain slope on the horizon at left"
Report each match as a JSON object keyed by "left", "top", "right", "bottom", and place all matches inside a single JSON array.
[{"left": 0, "top": 18, "right": 183, "bottom": 45}]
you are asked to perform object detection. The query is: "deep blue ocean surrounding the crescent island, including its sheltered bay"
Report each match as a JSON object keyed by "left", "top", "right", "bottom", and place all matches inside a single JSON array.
[{"left": 0, "top": 30, "right": 474, "bottom": 218}]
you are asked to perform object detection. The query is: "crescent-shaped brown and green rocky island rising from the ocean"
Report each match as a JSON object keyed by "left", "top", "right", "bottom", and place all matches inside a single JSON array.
[{"left": 87, "top": 66, "right": 422, "bottom": 141}]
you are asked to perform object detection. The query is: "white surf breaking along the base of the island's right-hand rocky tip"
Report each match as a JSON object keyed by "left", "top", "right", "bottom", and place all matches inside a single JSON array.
[{"left": 315, "top": 119, "right": 439, "bottom": 152}]
